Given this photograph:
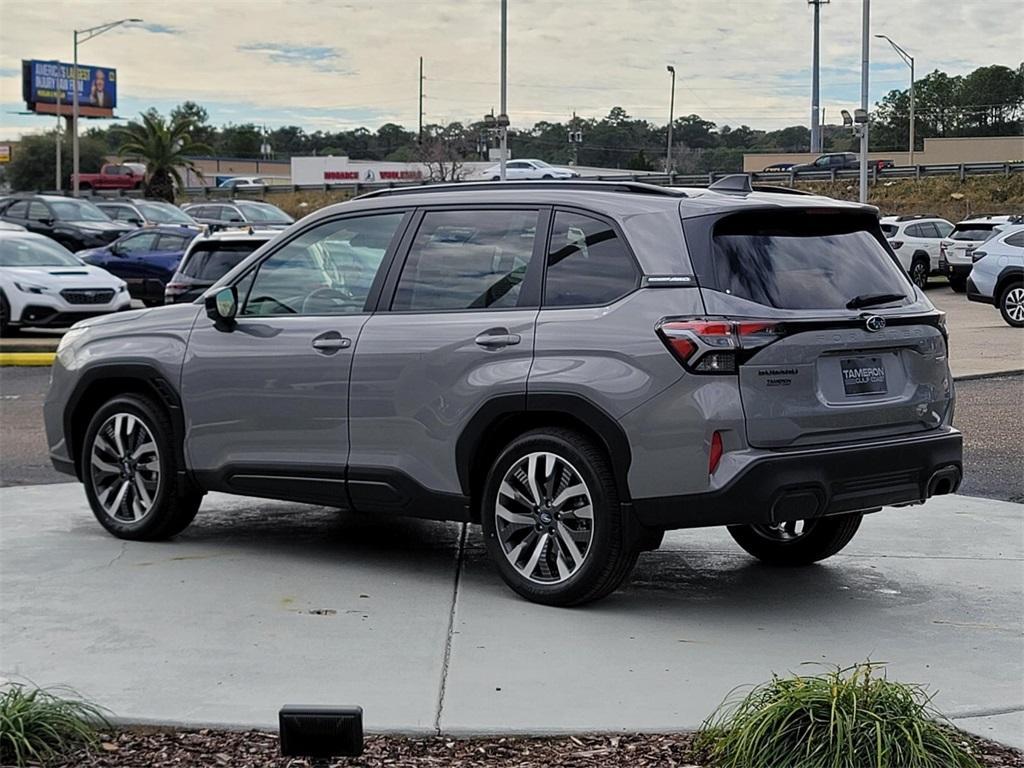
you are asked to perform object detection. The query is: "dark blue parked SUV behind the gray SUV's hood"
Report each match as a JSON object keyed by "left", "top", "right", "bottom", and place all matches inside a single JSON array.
[{"left": 78, "top": 226, "right": 199, "bottom": 306}]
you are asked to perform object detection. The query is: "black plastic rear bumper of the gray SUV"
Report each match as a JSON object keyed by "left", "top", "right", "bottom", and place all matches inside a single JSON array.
[{"left": 633, "top": 427, "right": 963, "bottom": 528}]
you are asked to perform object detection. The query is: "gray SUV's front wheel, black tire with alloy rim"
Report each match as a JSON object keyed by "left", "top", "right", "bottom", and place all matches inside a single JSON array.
[{"left": 79, "top": 394, "right": 203, "bottom": 542}]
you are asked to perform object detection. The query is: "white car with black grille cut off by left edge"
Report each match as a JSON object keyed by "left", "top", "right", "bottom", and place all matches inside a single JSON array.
[{"left": 0, "top": 229, "right": 131, "bottom": 336}]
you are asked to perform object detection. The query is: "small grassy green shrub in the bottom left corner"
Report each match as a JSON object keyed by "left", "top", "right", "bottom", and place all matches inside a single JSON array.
[{"left": 0, "top": 683, "right": 108, "bottom": 766}]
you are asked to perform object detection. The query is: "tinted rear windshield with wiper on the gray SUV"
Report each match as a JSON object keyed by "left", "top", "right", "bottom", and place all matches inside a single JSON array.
[{"left": 698, "top": 211, "right": 909, "bottom": 309}]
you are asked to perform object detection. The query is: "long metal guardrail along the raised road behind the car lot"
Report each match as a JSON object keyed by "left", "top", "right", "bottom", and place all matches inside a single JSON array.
[{"left": 58, "top": 162, "right": 1024, "bottom": 202}]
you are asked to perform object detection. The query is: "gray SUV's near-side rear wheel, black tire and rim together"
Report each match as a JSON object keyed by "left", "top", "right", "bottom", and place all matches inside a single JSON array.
[{"left": 480, "top": 428, "right": 639, "bottom": 606}]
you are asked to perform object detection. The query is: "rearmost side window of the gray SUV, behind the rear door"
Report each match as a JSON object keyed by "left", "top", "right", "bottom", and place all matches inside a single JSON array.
[{"left": 544, "top": 211, "right": 639, "bottom": 307}]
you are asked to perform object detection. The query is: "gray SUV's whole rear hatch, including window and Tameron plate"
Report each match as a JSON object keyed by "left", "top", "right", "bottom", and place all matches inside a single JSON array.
[{"left": 687, "top": 209, "right": 952, "bottom": 447}]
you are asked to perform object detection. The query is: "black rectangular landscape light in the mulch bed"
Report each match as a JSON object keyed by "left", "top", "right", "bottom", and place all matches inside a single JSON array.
[{"left": 278, "top": 705, "right": 362, "bottom": 760}]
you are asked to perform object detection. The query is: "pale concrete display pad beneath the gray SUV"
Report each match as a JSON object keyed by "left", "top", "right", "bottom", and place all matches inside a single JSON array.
[{"left": 0, "top": 484, "right": 1024, "bottom": 748}]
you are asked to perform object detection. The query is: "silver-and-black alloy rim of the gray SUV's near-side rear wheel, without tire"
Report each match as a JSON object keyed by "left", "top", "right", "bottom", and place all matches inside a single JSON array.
[{"left": 495, "top": 452, "right": 594, "bottom": 585}]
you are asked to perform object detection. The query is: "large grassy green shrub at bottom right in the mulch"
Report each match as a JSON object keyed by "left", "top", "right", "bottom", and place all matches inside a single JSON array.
[{"left": 696, "top": 663, "right": 979, "bottom": 768}]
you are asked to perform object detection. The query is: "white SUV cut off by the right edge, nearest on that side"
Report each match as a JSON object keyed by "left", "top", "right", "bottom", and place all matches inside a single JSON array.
[{"left": 967, "top": 224, "right": 1024, "bottom": 328}]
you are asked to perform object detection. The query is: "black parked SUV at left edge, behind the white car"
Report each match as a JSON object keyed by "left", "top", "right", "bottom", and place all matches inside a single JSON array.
[{"left": 0, "top": 195, "right": 134, "bottom": 253}]
